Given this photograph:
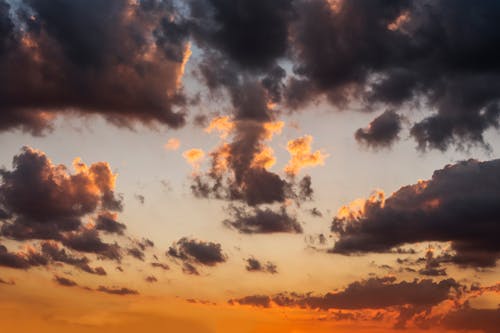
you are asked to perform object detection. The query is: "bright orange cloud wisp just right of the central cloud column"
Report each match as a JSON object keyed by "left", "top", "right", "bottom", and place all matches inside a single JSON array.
[{"left": 285, "top": 135, "right": 328, "bottom": 176}]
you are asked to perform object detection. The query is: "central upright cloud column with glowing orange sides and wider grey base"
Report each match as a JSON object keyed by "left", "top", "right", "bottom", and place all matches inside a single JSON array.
[{"left": 191, "top": 114, "right": 312, "bottom": 206}]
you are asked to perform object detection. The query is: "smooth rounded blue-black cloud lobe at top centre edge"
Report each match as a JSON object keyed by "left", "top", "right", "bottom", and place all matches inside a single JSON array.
[{"left": 190, "top": 0, "right": 294, "bottom": 69}]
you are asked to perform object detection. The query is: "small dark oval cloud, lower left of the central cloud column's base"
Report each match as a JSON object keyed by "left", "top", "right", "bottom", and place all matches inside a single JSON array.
[{"left": 166, "top": 237, "right": 227, "bottom": 266}]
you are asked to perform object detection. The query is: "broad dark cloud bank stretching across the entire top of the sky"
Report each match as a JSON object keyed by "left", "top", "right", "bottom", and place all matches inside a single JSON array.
[{"left": 0, "top": 0, "right": 500, "bottom": 150}]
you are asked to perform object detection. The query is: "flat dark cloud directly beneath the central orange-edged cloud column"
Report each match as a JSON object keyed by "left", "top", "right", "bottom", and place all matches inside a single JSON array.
[{"left": 224, "top": 206, "right": 302, "bottom": 234}]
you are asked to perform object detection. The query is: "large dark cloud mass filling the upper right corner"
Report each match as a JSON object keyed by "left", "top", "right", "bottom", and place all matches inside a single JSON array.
[{"left": 288, "top": 0, "right": 500, "bottom": 150}]
